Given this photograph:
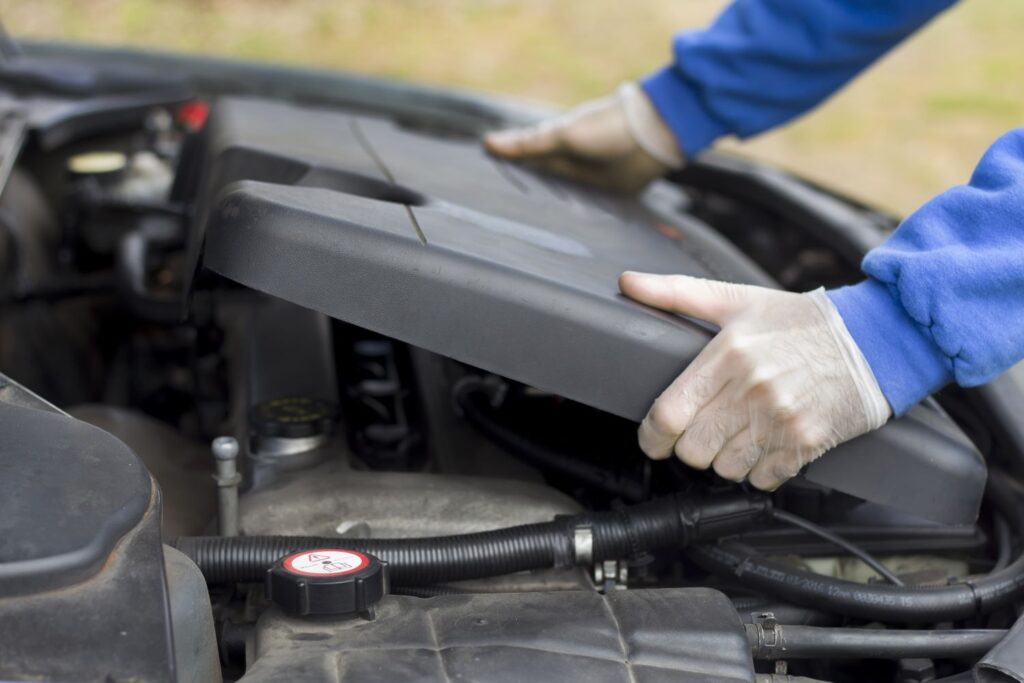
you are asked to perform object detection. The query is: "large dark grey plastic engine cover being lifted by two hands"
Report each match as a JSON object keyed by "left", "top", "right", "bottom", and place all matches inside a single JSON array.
[{"left": 190, "top": 98, "right": 985, "bottom": 523}]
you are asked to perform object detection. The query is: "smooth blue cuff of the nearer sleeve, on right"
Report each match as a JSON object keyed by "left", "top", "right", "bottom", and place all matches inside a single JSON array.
[{"left": 828, "top": 279, "right": 953, "bottom": 415}]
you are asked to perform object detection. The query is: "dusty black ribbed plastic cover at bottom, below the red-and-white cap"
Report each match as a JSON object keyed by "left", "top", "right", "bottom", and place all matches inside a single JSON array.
[{"left": 242, "top": 588, "right": 754, "bottom": 683}]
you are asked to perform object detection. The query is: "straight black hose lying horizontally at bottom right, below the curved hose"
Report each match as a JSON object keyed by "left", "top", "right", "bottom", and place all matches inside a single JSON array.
[{"left": 745, "top": 624, "right": 1007, "bottom": 659}]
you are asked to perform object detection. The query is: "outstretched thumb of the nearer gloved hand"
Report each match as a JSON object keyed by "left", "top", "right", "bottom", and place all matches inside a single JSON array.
[{"left": 618, "top": 271, "right": 757, "bottom": 327}]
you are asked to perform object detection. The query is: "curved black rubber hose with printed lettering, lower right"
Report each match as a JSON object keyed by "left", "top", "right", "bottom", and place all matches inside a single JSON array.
[{"left": 688, "top": 471, "right": 1024, "bottom": 624}]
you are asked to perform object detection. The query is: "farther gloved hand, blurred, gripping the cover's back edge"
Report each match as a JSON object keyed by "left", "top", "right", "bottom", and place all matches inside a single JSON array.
[{"left": 483, "top": 83, "right": 683, "bottom": 191}]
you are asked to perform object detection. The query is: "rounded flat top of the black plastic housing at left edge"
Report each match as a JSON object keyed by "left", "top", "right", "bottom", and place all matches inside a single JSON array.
[{"left": 0, "top": 403, "right": 152, "bottom": 596}]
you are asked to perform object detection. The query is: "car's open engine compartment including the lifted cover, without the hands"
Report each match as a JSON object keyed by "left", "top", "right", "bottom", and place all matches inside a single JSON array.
[{"left": 0, "top": 44, "right": 1024, "bottom": 683}]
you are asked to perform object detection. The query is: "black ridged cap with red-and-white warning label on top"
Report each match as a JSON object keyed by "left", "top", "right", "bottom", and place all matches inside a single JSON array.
[{"left": 266, "top": 548, "right": 388, "bottom": 616}]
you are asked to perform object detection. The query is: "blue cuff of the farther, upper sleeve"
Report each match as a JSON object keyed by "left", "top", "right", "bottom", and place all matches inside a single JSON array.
[{"left": 640, "top": 67, "right": 730, "bottom": 158}]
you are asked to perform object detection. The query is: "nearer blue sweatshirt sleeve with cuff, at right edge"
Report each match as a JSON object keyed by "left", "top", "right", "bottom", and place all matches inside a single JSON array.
[{"left": 829, "top": 128, "right": 1024, "bottom": 415}]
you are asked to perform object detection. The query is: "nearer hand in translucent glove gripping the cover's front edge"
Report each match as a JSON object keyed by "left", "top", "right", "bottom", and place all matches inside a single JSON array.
[{"left": 620, "top": 272, "right": 891, "bottom": 490}]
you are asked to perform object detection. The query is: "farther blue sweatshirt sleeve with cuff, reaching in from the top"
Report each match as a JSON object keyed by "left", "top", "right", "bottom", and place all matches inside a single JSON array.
[{"left": 642, "top": 0, "right": 955, "bottom": 157}]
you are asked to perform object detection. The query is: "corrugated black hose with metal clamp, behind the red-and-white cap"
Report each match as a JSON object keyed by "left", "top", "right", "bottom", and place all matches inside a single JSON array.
[{"left": 176, "top": 496, "right": 771, "bottom": 586}]
